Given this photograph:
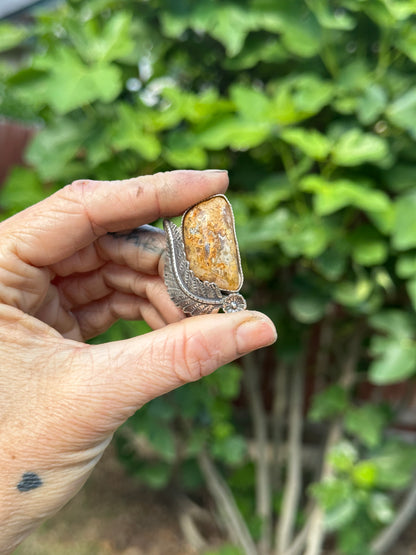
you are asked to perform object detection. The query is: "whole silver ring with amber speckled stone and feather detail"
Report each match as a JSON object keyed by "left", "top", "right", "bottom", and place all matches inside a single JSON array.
[{"left": 163, "top": 195, "right": 247, "bottom": 316}]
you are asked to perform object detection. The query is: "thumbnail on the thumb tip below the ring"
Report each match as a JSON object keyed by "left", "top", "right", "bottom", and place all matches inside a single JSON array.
[{"left": 237, "top": 312, "right": 277, "bottom": 354}]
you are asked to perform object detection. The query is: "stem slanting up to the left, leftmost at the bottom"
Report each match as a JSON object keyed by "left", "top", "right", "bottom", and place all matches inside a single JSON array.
[{"left": 198, "top": 451, "right": 258, "bottom": 555}]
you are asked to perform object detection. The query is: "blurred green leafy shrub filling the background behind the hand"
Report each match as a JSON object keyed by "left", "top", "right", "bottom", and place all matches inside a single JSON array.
[{"left": 0, "top": 0, "right": 416, "bottom": 555}]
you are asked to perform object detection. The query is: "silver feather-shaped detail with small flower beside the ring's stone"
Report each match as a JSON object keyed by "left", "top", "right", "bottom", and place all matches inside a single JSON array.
[{"left": 163, "top": 219, "right": 246, "bottom": 316}]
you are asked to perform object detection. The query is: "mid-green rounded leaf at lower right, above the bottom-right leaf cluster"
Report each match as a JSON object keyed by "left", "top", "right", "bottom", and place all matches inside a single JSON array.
[{"left": 344, "top": 404, "right": 391, "bottom": 448}]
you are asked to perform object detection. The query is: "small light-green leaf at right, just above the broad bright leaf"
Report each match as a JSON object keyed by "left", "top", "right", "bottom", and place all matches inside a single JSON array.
[{"left": 332, "top": 129, "right": 389, "bottom": 166}]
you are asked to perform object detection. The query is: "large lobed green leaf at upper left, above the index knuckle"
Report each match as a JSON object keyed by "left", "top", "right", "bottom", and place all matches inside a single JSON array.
[{"left": 37, "top": 48, "right": 122, "bottom": 115}]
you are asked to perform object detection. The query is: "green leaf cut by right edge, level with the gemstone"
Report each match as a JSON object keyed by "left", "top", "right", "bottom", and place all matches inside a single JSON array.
[{"left": 392, "top": 192, "right": 416, "bottom": 251}]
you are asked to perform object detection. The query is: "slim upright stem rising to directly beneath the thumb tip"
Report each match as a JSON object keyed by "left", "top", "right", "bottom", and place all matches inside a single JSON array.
[{"left": 242, "top": 353, "right": 272, "bottom": 555}]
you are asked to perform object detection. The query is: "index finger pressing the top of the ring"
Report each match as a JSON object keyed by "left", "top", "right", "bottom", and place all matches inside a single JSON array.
[{"left": 4, "top": 170, "right": 228, "bottom": 266}]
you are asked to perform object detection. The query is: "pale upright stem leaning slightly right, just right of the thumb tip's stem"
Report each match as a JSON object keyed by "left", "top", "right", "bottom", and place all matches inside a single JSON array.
[{"left": 275, "top": 353, "right": 305, "bottom": 555}]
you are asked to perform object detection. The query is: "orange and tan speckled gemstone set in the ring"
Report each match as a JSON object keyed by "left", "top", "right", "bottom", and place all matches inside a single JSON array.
[{"left": 182, "top": 195, "right": 243, "bottom": 292}]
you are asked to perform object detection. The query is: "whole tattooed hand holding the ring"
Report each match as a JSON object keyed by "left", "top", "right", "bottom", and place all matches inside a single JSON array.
[{"left": 0, "top": 171, "right": 276, "bottom": 554}]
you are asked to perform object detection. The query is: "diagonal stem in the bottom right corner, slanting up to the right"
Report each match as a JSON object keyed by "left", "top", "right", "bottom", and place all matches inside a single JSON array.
[{"left": 371, "top": 477, "right": 416, "bottom": 555}]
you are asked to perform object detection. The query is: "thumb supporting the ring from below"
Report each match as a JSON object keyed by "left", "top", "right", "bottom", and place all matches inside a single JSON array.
[{"left": 69, "top": 311, "right": 277, "bottom": 432}]
